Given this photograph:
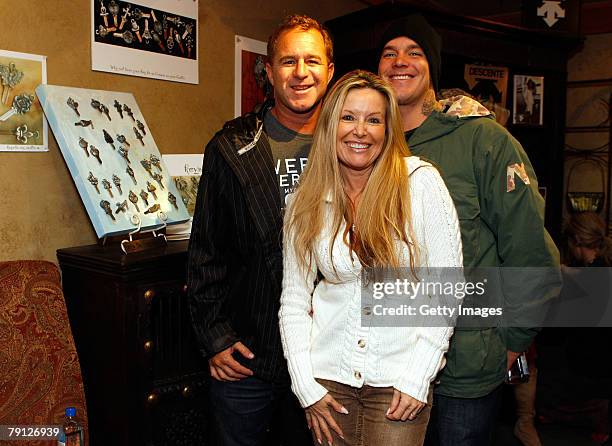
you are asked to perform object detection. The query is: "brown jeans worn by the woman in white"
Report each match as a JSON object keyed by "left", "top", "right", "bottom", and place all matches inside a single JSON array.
[{"left": 313, "top": 379, "right": 432, "bottom": 446}]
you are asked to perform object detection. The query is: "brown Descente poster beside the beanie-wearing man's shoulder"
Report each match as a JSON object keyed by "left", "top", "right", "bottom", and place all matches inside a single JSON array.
[{"left": 463, "top": 64, "right": 510, "bottom": 126}]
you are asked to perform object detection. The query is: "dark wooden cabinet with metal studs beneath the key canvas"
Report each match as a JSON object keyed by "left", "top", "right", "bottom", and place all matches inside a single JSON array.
[{"left": 57, "top": 241, "right": 211, "bottom": 446}]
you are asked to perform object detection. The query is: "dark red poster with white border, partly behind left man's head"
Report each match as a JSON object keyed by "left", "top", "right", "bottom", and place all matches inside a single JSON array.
[{"left": 234, "top": 36, "right": 272, "bottom": 117}]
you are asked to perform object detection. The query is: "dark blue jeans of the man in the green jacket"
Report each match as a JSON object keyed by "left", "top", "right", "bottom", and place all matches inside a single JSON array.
[{"left": 425, "top": 386, "right": 502, "bottom": 446}]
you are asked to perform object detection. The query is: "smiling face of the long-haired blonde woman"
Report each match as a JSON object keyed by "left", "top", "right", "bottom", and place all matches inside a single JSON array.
[{"left": 336, "top": 88, "right": 387, "bottom": 175}]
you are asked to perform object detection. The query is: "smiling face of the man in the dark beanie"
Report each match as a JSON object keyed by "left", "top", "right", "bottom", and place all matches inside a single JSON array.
[{"left": 378, "top": 37, "right": 431, "bottom": 107}]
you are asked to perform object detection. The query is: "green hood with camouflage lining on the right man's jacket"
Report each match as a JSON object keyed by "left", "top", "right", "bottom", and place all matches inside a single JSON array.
[{"left": 410, "top": 95, "right": 495, "bottom": 147}]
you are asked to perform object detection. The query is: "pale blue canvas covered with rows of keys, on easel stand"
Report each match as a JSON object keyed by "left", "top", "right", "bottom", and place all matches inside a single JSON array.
[{"left": 36, "top": 83, "right": 189, "bottom": 238}]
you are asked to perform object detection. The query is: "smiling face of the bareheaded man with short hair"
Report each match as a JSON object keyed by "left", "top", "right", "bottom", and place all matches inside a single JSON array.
[{"left": 266, "top": 28, "right": 334, "bottom": 115}]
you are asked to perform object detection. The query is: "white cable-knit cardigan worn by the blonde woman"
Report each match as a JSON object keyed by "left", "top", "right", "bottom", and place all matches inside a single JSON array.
[{"left": 279, "top": 157, "right": 463, "bottom": 407}]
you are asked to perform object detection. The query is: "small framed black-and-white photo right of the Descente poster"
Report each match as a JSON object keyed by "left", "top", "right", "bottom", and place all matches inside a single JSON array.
[{"left": 512, "top": 74, "right": 544, "bottom": 126}]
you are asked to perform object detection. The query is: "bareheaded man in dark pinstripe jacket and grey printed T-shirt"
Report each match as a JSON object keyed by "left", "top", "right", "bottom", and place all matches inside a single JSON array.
[{"left": 188, "top": 15, "right": 334, "bottom": 445}]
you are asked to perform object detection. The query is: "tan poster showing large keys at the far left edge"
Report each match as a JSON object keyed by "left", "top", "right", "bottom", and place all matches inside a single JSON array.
[{"left": 0, "top": 50, "right": 49, "bottom": 152}]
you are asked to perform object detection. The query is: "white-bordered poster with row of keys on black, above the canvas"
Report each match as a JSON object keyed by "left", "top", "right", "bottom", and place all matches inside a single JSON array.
[{"left": 90, "top": 0, "right": 199, "bottom": 84}]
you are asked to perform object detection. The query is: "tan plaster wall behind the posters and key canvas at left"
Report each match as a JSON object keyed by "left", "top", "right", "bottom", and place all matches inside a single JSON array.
[{"left": 0, "top": 0, "right": 364, "bottom": 261}]
